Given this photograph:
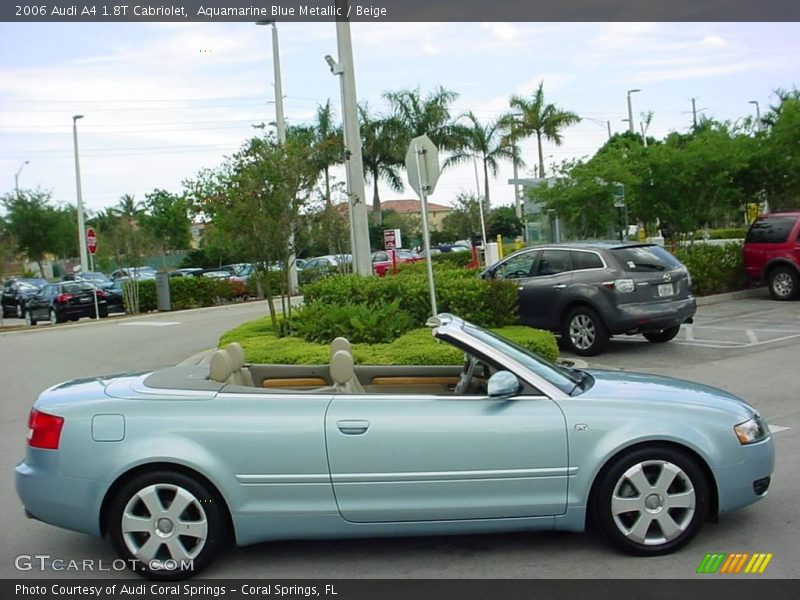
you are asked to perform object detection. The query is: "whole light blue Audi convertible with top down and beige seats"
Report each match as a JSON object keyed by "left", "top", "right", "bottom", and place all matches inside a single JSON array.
[{"left": 16, "top": 315, "right": 774, "bottom": 578}]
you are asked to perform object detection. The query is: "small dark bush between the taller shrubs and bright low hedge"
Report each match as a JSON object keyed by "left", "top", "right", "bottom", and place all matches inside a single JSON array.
[{"left": 291, "top": 301, "right": 415, "bottom": 344}]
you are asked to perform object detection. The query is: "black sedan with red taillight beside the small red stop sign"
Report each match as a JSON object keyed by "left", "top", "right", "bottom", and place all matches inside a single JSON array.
[{"left": 25, "top": 281, "right": 108, "bottom": 325}]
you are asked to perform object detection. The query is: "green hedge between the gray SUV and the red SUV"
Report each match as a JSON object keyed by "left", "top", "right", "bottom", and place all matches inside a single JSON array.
[{"left": 675, "top": 242, "right": 748, "bottom": 296}]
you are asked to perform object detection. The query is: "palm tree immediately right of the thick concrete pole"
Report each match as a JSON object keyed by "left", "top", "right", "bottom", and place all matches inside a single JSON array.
[{"left": 358, "top": 105, "right": 403, "bottom": 225}]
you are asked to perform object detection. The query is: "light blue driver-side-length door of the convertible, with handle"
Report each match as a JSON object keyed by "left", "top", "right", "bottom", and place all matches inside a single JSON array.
[{"left": 325, "top": 386, "right": 568, "bottom": 523}]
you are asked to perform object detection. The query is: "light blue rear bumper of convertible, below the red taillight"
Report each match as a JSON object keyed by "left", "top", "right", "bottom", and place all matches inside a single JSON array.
[{"left": 15, "top": 458, "right": 105, "bottom": 536}]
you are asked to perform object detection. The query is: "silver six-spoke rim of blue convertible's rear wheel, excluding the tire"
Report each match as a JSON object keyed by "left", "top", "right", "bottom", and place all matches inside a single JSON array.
[{"left": 121, "top": 484, "right": 209, "bottom": 564}]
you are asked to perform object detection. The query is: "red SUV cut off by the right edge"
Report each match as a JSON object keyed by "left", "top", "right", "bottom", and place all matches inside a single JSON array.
[{"left": 743, "top": 210, "right": 800, "bottom": 300}]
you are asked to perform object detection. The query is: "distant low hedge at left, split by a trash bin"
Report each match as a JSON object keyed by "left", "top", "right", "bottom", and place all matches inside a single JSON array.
[{"left": 126, "top": 277, "right": 247, "bottom": 312}]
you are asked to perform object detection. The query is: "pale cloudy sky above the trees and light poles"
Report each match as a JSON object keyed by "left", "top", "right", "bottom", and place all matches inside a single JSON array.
[{"left": 0, "top": 23, "right": 800, "bottom": 220}]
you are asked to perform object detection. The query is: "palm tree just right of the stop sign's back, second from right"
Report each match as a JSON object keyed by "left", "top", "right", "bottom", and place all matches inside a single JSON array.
[{"left": 444, "top": 111, "right": 524, "bottom": 211}]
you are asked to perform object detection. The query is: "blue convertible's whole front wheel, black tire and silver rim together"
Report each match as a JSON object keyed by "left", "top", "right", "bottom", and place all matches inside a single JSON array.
[{"left": 590, "top": 447, "right": 709, "bottom": 556}]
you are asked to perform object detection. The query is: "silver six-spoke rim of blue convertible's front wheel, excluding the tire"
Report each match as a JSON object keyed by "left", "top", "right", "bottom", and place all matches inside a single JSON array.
[{"left": 611, "top": 460, "right": 697, "bottom": 546}]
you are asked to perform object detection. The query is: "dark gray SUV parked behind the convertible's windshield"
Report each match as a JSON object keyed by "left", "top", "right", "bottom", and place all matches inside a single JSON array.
[{"left": 481, "top": 242, "right": 697, "bottom": 356}]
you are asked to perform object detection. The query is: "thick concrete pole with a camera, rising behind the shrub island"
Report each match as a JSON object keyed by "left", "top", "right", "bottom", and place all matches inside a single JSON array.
[{"left": 325, "top": 0, "right": 372, "bottom": 276}]
